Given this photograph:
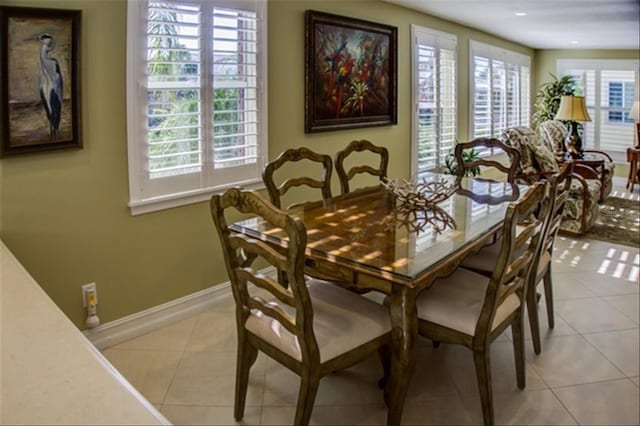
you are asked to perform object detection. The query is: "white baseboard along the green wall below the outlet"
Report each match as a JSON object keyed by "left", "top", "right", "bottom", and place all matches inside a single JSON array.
[{"left": 83, "top": 281, "right": 232, "bottom": 350}]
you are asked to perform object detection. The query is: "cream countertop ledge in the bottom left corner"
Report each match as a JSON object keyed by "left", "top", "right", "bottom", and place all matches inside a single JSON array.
[{"left": 0, "top": 241, "right": 171, "bottom": 425}]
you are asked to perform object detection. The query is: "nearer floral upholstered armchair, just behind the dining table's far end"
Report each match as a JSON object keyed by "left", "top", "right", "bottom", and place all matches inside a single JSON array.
[{"left": 501, "top": 127, "right": 602, "bottom": 234}]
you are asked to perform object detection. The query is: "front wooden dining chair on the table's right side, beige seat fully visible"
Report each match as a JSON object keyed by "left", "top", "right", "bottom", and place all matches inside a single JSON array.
[{"left": 416, "top": 182, "right": 548, "bottom": 425}]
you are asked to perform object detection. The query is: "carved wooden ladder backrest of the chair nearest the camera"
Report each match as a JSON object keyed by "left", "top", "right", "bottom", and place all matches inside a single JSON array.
[{"left": 210, "top": 188, "right": 320, "bottom": 361}]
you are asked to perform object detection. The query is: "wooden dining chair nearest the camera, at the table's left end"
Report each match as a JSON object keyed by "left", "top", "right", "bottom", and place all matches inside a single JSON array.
[{"left": 211, "top": 188, "right": 391, "bottom": 425}]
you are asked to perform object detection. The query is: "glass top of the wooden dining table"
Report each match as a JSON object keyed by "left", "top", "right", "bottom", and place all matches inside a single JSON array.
[{"left": 230, "top": 174, "right": 524, "bottom": 280}]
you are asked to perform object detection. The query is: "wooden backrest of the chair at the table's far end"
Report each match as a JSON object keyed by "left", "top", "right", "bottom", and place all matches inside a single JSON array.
[{"left": 454, "top": 138, "right": 520, "bottom": 182}]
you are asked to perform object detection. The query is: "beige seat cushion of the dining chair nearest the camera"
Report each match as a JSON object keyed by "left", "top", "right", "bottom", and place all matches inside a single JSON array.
[{"left": 245, "top": 279, "right": 391, "bottom": 362}]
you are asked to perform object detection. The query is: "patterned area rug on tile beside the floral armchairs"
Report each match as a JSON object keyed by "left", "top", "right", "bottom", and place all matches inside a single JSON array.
[{"left": 585, "top": 197, "right": 640, "bottom": 247}]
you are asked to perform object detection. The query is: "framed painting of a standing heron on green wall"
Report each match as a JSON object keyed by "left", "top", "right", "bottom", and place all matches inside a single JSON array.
[{"left": 0, "top": 6, "right": 82, "bottom": 157}]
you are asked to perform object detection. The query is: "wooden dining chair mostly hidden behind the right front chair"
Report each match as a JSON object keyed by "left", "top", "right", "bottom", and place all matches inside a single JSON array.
[{"left": 460, "top": 162, "right": 572, "bottom": 354}]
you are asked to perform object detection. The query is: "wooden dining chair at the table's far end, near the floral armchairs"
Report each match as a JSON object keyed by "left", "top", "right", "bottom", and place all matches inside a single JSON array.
[{"left": 454, "top": 138, "right": 520, "bottom": 182}]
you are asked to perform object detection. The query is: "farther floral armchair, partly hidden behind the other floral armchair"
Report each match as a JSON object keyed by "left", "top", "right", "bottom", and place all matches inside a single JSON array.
[{"left": 538, "top": 120, "right": 615, "bottom": 202}]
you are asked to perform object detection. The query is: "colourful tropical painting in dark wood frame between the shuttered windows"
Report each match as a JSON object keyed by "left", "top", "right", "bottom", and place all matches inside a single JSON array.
[{"left": 304, "top": 10, "right": 398, "bottom": 133}]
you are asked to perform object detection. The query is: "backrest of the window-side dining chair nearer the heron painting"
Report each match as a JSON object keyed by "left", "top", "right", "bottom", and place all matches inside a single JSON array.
[{"left": 262, "top": 147, "right": 333, "bottom": 208}]
